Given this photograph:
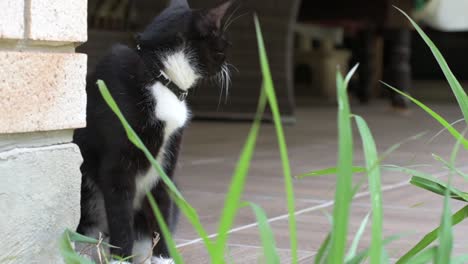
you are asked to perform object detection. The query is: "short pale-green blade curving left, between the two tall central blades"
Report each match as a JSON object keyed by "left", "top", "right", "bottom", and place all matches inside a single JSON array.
[{"left": 249, "top": 203, "right": 280, "bottom": 264}]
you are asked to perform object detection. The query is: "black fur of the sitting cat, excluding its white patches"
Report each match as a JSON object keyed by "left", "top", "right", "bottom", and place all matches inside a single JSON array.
[{"left": 74, "top": 0, "right": 230, "bottom": 257}]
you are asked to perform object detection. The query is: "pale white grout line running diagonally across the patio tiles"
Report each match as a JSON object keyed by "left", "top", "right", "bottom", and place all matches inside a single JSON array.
[{"left": 177, "top": 166, "right": 468, "bottom": 248}]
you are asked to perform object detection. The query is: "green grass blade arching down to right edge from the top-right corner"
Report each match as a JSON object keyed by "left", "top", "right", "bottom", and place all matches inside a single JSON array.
[{"left": 397, "top": 8, "right": 468, "bottom": 125}]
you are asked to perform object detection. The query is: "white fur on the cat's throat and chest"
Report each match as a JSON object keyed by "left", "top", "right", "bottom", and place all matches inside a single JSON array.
[{"left": 133, "top": 50, "right": 199, "bottom": 209}]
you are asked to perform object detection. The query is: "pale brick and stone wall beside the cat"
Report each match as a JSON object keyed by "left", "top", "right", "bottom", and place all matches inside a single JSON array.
[{"left": 0, "top": 0, "right": 87, "bottom": 263}]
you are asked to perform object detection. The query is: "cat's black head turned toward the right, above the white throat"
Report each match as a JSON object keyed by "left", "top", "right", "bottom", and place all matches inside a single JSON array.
[{"left": 137, "top": 0, "right": 232, "bottom": 78}]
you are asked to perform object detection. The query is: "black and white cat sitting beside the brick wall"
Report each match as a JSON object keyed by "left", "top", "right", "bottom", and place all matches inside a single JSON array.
[{"left": 74, "top": 0, "right": 231, "bottom": 264}]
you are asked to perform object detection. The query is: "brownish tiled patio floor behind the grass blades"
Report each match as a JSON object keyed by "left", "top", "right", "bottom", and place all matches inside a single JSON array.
[{"left": 176, "top": 102, "right": 468, "bottom": 264}]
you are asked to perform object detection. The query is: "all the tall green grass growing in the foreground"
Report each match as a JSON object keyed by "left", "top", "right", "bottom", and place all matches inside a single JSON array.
[{"left": 60, "top": 8, "right": 468, "bottom": 264}]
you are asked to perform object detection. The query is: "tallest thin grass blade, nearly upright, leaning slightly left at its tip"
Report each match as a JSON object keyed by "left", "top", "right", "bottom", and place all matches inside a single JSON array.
[{"left": 254, "top": 15, "right": 298, "bottom": 264}]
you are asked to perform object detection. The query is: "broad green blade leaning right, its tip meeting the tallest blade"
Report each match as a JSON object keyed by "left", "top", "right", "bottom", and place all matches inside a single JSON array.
[{"left": 215, "top": 85, "right": 267, "bottom": 258}]
